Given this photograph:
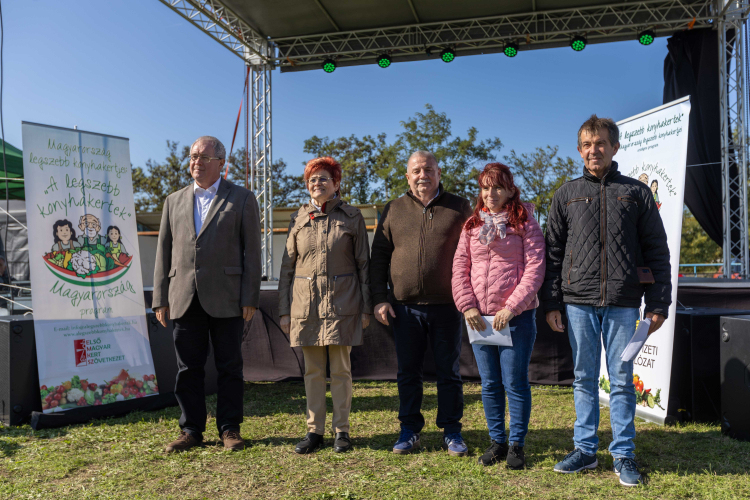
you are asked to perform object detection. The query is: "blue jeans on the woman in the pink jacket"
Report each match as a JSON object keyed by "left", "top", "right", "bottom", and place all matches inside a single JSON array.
[{"left": 471, "top": 309, "right": 536, "bottom": 446}]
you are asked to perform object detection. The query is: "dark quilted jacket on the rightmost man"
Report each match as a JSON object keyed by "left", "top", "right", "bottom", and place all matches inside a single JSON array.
[{"left": 541, "top": 162, "right": 672, "bottom": 316}]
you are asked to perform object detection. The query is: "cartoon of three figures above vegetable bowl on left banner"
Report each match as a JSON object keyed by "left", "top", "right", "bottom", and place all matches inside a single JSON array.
[{"left": 43, "top": 214, "right": 132, "bottom": 285}]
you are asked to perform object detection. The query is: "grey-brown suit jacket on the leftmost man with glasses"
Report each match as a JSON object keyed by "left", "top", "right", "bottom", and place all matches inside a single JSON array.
[{"left": 151, "top": 179, "right": 261, "bottom": 318}]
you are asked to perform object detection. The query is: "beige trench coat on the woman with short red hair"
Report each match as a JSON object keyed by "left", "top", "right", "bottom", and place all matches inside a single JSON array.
[{"left": 279, "top": 199, "right": 372, "bottom": 347}]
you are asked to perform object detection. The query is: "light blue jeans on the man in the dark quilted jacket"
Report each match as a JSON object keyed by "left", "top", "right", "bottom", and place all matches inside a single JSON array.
[{"left": 565, "top": 304, "right": 639, "bottom": 458}]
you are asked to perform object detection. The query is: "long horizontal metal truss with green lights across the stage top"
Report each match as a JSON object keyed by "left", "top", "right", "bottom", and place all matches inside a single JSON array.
[{"left": 270, "top": 0, "right": 716, "bottom": 71}]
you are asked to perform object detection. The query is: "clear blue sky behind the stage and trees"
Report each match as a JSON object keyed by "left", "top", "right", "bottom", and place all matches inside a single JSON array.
[{"left": 2, "top": 0, "right": 667, "bottom": 179}]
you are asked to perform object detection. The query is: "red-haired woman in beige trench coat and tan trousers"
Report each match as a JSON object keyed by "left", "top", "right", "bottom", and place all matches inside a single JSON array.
[{"left": 279, "top": 156, "right": 372, "bottom": 454}]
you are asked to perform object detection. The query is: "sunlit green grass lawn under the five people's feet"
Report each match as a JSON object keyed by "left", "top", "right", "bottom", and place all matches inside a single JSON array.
[{"left": 0, "top": 381, "right": 750, "bottom": 500}]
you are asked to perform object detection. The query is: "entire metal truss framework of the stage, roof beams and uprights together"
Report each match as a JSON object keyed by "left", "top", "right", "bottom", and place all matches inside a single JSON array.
[{"left": 160, "top": 0, "right": 750, "bottom": 278}]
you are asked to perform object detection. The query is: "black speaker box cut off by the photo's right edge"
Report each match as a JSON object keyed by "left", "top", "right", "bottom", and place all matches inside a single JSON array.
[{"left": 720, "top": 316, "right": 750, "bottom": 441}]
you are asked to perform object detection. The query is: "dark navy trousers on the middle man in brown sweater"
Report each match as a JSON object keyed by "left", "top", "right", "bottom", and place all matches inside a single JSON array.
[{"left": 393, "top": 304, "right": 464, "bottom": 433}]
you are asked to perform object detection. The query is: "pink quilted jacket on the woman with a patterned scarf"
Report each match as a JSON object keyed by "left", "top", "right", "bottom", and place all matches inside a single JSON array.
[{"left": 452, "top": 203, "right": 545, "bottom": 316}]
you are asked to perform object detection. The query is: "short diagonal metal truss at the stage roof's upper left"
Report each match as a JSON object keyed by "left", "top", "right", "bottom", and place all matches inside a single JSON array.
[{"left": 159, "top": 0, "right": 271, "bottom": 63}]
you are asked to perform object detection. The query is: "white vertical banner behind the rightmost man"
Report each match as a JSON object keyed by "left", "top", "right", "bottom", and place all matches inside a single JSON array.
[{"left": 599, "top": 96, "right": 690, "bottom": 424}]
